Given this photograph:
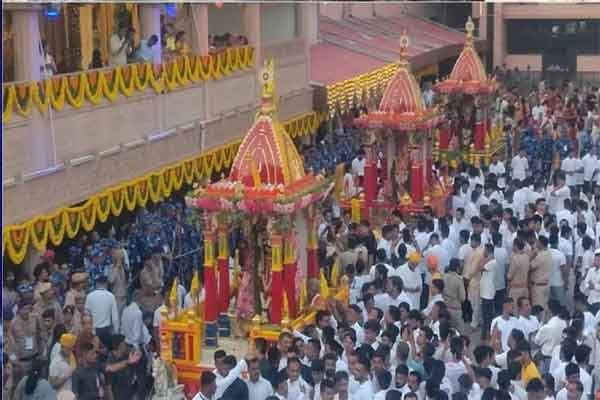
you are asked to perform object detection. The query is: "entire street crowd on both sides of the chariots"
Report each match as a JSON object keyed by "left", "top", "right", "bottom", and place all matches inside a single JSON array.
[{"left": 3, "top": 76, "right": 600, "bottom": 400}]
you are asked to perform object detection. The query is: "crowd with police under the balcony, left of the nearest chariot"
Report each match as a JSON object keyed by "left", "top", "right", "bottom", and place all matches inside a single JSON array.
[{"left": 2, "top": 201, "right": 202, "bottom": 400}]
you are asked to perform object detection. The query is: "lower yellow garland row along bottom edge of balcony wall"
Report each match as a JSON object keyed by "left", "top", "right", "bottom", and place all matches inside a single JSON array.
[{"left": 2, "top": 112, "right": 325, "bottom": 264}]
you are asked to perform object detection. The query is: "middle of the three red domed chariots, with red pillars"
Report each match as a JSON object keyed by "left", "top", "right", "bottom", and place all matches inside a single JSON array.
[{"left": 352, "top": 32, "right": 447, "bottom": 222}]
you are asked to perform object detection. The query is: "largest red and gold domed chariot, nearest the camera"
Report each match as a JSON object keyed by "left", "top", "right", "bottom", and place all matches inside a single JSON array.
[{"left": 160, "top": 60, "right": 348, "bottom": 382}]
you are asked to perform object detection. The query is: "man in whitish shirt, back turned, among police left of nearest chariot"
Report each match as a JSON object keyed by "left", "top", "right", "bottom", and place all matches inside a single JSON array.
[{"left": 85, "top": 275, "right": 119, "bottom": 336}]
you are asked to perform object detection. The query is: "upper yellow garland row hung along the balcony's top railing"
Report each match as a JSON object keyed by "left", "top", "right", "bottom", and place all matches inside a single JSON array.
[{"left": 2, "top": 47, "right": 254, "bottom": 123}]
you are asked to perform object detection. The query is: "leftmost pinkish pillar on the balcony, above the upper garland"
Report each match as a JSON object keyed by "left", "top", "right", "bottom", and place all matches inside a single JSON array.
[{"left": 12, "top": 6, "right": 44, "bottom": 81}]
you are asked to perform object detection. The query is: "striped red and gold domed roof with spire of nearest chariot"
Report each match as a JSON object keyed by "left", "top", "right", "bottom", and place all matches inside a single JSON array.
[{"left": 190, "top": 59, "right": 333, "bottom": 214}]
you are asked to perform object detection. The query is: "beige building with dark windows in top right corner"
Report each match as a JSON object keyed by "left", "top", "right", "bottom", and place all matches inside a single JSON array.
[{"left": 473, "top": 2, "right": 600, "bottom": 81}]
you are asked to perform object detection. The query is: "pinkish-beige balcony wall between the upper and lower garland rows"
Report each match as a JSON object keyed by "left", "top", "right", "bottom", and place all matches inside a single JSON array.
[{"left": 2, "top": 4, "right": 313, "bottom": 224}]
